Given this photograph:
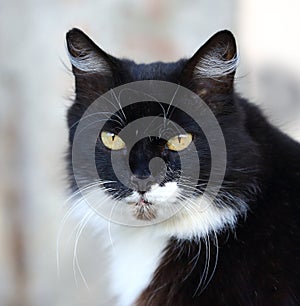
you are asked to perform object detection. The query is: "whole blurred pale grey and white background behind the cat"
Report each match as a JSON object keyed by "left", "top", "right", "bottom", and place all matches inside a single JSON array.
[{"left": 0, "top": 0, "right": 300, "bottom": 306}]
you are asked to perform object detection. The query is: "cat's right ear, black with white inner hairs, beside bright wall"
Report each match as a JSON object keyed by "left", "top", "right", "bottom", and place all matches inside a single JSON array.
[{"left": 183, "top": 30, "right": 238, "bottom": 97}]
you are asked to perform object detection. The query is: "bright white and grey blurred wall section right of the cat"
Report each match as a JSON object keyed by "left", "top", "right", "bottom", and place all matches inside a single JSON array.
[{"left": 235, "top": 0, "right": 300, "bottom": 141}]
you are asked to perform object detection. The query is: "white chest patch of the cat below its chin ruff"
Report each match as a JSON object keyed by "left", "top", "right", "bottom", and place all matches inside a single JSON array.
[{"left": 104, "top": 226, "right": 168, "bottom": 306}]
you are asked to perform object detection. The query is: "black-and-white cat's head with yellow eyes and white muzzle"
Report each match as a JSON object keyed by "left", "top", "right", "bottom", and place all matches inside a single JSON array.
[{"left": 67, "top": 29, "right": 257, "bottom": 237}]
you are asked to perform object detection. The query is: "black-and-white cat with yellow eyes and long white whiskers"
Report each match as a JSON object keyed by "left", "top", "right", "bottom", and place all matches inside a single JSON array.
[{"left": 66, "top": 28, "right": 300, "bottom": 306}]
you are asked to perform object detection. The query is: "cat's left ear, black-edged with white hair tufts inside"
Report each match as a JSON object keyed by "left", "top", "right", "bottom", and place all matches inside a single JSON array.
[{"left": 66, "top": 28, "right": 118, "bottom": 97}]
